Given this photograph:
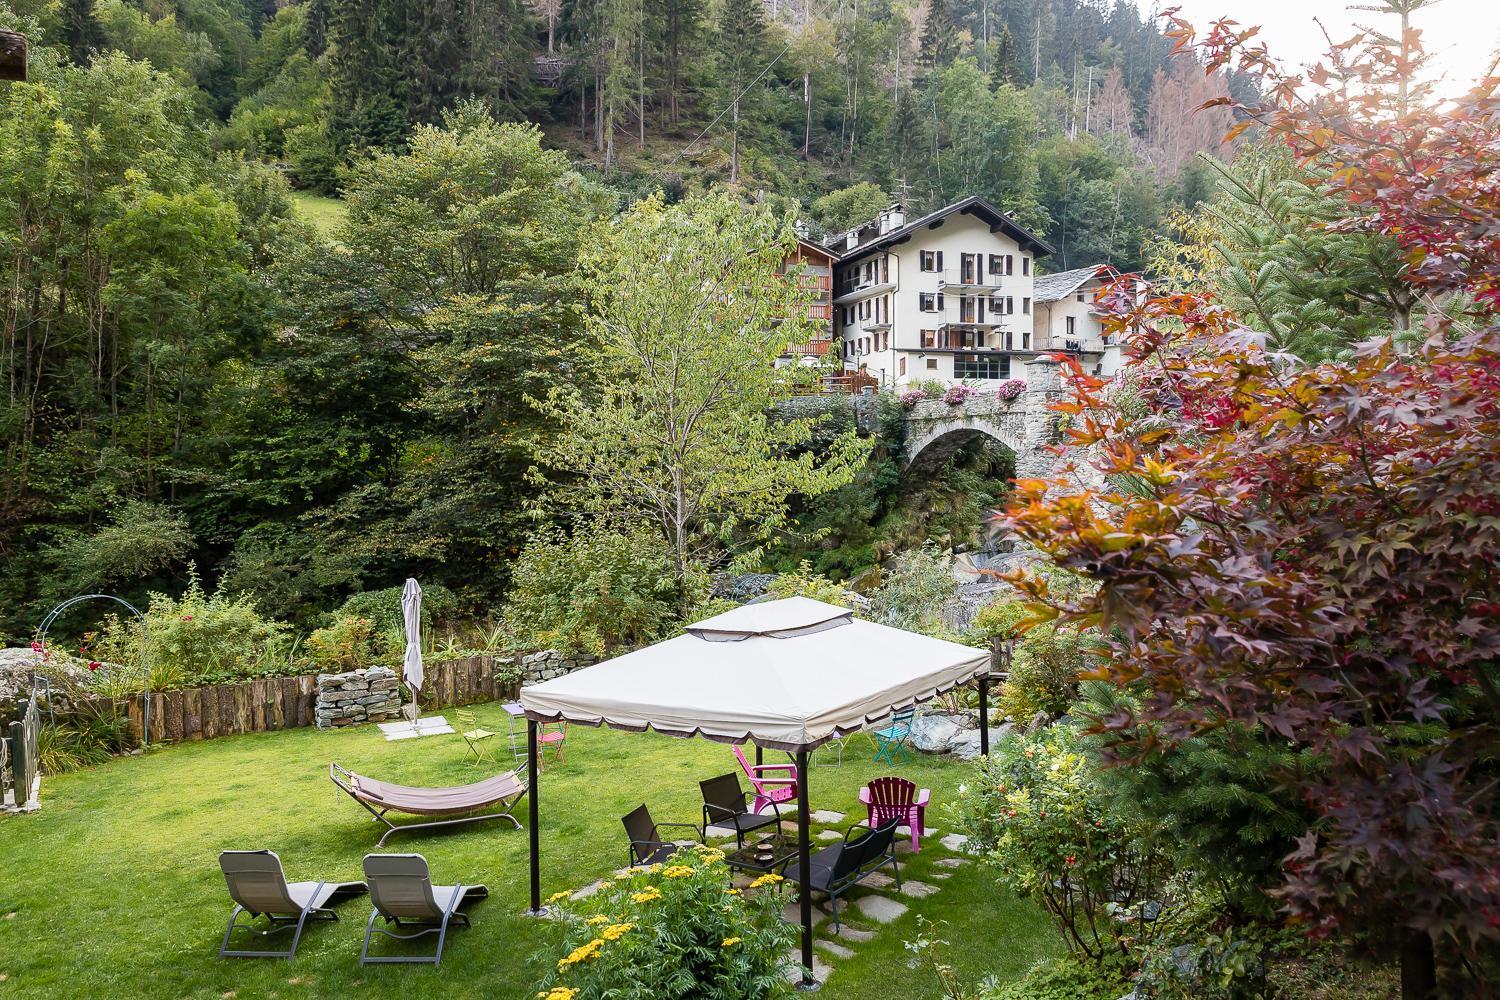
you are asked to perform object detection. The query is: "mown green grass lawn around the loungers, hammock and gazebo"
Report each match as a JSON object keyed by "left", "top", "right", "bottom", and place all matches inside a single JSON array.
[{"left": 0, "top": 705, "right": 1061, "bottom": 1000}]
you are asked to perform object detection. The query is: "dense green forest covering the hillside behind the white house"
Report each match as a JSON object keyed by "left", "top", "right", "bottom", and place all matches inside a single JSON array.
[{"left": 0, "top": 0, "right": 1241, "bottom": 637}]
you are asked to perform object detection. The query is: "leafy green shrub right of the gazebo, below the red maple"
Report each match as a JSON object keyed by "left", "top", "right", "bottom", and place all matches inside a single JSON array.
[{"left": 959, "top": 724, "right": 1172, "bottom": 961}]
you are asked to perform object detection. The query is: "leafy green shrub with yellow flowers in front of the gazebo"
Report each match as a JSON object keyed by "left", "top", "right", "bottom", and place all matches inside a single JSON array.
[{"left": 537, "top": 846, "right": 797, "bottom": 1000}]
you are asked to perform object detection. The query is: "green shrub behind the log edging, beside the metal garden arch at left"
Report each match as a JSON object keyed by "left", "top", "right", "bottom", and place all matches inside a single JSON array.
[{"left": 87, "top": 573, "right": 291, "bottom": 691}]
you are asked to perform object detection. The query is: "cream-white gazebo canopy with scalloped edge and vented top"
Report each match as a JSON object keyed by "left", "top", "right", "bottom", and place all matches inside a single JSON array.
[{"left": 521, "top": 597, "right": 990, "bottom": 753}]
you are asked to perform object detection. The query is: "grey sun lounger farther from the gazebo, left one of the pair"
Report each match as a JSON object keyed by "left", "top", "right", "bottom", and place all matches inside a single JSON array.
[{"left": 219, "top": 850, "right": 365, "bottom": 958}]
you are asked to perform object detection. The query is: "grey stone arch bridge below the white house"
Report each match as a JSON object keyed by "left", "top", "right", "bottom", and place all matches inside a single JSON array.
[{"left": 906, "top": 357, "right": 1062, "bottom": 478}]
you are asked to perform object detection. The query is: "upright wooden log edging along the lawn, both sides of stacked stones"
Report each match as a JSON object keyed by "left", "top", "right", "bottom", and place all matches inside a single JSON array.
[{"left": 107, "top": 655, "right": 519, "bottom": 744}]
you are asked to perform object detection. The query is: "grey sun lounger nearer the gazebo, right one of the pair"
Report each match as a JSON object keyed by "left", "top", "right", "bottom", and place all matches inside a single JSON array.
[{"left": 360, "top": 855, "right": 489, "bottom": 966}]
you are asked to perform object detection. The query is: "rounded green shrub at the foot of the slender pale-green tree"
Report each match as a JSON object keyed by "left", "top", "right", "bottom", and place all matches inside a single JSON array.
[{"left": 503, "top": 525, "right": 692, "bottom": 657}]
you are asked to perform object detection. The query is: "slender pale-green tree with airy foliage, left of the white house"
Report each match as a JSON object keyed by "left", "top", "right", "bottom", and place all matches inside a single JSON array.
[{"left": 534, "top": 195, "right": 869, "bottom": 590}]
